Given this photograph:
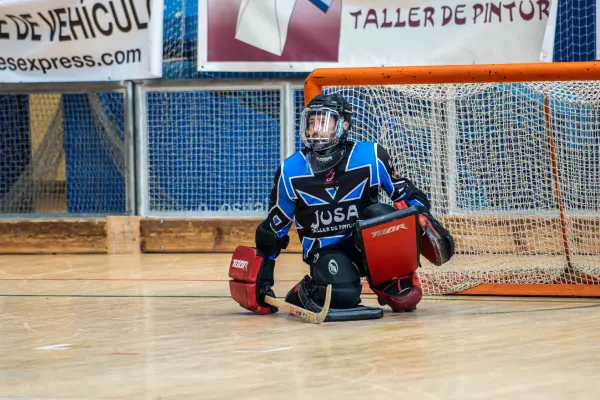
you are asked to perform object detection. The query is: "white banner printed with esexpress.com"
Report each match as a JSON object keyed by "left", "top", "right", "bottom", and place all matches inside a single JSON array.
[{"left": 0, "top": 0, "right": 163, "bottom": 82}]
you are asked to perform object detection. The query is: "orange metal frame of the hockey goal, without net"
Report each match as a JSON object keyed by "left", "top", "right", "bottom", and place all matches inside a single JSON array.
[{"left": 304, "top": 62, "right": 600, "bottom": 297}]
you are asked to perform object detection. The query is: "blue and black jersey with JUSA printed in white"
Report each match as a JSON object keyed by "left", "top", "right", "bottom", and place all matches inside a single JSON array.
[{"left": 268, "top": 141, "right": 420, "bottom": 259}]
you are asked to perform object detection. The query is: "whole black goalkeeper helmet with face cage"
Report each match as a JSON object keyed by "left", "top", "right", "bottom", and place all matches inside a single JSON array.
[{"left": 300, "top": 93, "right": 352, "bottom": 154}]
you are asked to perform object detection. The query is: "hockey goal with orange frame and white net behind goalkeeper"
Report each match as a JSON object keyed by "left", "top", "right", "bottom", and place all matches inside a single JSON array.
[{"left": 305, "top": 63, "right": 600, "bottom": 296}]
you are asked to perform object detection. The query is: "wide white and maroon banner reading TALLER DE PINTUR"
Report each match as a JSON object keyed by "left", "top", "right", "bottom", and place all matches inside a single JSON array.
[{"left": 198, "top": 0, "right": 551, "bottom": 71}]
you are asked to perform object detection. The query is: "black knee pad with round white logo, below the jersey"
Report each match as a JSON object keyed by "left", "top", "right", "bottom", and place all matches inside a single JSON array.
[{"left": 310, "top": 251, "right": 362, "bottom": 308}]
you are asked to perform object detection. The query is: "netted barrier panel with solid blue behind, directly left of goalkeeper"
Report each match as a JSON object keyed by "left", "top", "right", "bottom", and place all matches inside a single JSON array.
[{"left": 146, "top": 88, "right": 282, "bottom": 216}]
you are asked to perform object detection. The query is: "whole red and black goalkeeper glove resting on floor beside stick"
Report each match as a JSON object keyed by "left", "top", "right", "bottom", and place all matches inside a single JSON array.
[{"left": 229, "top": 246, "right": 279, "bottom": 314}]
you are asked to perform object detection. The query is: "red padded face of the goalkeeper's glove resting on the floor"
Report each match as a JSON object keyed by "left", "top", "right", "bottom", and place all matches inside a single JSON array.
[{"left": 229, "top": 246, "right": 273, "bottom": 314}]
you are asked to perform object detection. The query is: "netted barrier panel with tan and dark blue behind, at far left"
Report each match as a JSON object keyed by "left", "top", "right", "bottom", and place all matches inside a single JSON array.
[{"left": 0, "top": 92, "right": 131, "bottom": 217}]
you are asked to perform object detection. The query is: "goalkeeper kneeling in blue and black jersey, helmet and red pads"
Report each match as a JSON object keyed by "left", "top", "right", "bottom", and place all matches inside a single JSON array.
[{"left": 230, "top": 94, "right": 454, "bottom": 321}]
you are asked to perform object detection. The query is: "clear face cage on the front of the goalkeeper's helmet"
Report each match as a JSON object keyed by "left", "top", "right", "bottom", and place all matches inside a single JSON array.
[{"left": 300, "top": 107, "right": 344, "bottom": 151}]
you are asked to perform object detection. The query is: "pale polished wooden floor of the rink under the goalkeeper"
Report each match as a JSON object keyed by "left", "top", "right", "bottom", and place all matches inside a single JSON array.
[{"left": 0, "top": 254, "right": 600, "bottom": 400}]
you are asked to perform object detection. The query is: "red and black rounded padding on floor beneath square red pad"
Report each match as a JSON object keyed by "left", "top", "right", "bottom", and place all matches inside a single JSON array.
[{"left": 372, "top": 272, "right": 423, "bottom": 312}]
